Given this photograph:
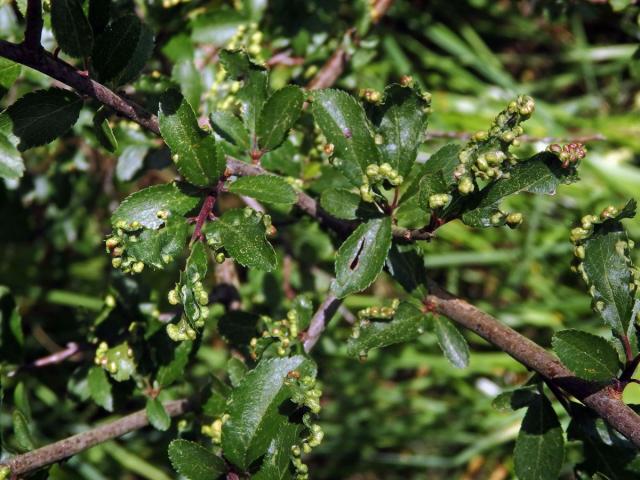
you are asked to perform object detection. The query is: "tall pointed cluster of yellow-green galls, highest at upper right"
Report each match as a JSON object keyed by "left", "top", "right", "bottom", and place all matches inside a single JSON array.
[{"left": 454, "top": 95, "right": 535, "bottom": 195}]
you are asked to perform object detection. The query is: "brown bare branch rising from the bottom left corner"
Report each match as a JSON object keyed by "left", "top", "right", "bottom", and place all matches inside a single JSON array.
[{"left": 0, "top": 399, "right": 191, "bottom": 478}]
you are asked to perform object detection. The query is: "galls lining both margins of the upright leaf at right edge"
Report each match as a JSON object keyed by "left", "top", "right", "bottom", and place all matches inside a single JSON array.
[{"left": 570, "top": 205, "right": 640, "bottom": 311}]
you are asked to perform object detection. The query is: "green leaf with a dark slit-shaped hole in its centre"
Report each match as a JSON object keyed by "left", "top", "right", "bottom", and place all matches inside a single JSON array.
[{"left": 331, "top": 217, "right": 391, "bottom": 298}]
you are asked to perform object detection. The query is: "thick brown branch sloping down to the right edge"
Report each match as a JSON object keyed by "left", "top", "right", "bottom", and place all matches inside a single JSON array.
[{"left": 426, "top": 281, "right": 640, "bottom": 447}]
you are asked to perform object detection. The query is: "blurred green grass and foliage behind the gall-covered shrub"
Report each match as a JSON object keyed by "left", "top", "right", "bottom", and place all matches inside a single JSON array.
[{"left": 0, "top": 0, "right": 640, "bottom": 480}]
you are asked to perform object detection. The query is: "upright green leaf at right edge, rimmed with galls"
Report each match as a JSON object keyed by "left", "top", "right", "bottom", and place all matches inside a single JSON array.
[{"left": 581, "top": 202, "right": 635, "bottom": 337}]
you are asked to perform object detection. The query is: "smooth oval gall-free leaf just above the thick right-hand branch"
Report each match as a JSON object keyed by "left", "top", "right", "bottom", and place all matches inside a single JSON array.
[{"left": 552, "top": 330, "right": 619, "bottom": 381}]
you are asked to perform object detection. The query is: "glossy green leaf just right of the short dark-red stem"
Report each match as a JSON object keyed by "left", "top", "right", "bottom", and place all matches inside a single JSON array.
[{"left": 203, "top": 209, "right": 278, "bottom": 271}]
